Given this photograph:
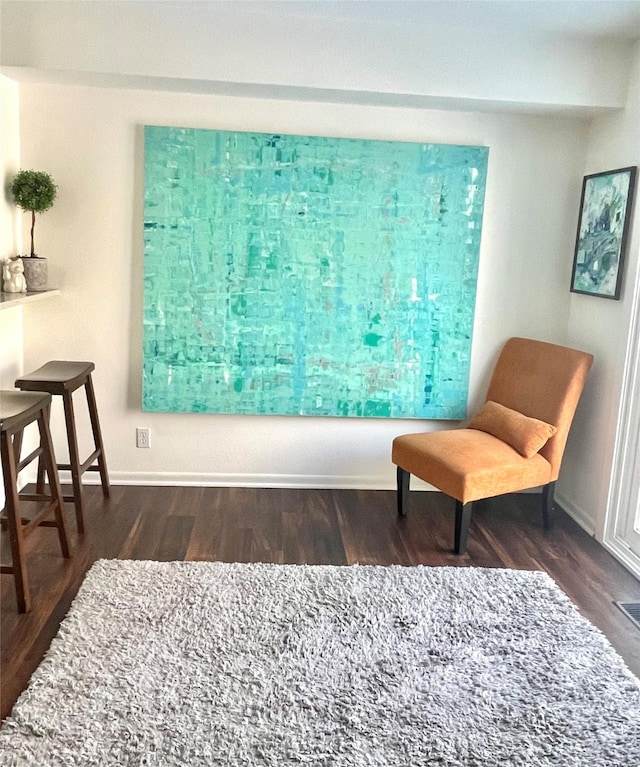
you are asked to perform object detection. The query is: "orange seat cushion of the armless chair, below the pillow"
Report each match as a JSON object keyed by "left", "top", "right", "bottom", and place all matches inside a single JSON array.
[{"left": 392, "top": 429, "right": 552, "bottom": 503}]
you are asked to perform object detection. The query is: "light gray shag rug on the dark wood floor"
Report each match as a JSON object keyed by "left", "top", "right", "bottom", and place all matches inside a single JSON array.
[{"left": 0, "top": 560, "right": 640, "bottom": 767}]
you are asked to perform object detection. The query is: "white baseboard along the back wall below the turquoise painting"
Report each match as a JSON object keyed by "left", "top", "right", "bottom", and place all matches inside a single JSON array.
[{"left": 60, "top": 471, "right": 435, "bottom": 491}]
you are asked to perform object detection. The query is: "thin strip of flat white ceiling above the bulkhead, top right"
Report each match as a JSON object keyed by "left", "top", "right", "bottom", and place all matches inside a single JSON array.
[{"left": 234, "top": 0, "right": 640, "bottom": 40}]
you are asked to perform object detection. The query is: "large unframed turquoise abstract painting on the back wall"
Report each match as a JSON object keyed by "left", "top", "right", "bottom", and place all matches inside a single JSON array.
[{"left": 143, "top": 126, "right": 488, "bottom": 419}]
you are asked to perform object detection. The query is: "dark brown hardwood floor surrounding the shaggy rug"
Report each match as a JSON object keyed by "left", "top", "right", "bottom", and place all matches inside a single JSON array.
[{"left": 0, "top": 486, "right": 640, "bottom": 718}]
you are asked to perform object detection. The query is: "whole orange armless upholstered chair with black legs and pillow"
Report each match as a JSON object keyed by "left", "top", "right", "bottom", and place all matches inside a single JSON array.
[{"left": 392, "top": 338, "right": 593, "bottom": 554}]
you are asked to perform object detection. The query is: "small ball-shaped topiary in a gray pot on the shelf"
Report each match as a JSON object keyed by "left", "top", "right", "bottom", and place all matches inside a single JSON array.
[{"left": 11, "top": 170, "right": 58, "bottom": 290}]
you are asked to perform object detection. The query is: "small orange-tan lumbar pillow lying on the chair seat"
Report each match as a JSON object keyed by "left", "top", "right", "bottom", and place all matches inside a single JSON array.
[{"left": 467, "top": 400, "right": 557, "bottom": 458}]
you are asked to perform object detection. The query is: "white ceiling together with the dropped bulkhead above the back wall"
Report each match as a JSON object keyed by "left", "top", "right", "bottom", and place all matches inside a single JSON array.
[{"left": 0, "top": 0, "right": 640, "bottom": 117}]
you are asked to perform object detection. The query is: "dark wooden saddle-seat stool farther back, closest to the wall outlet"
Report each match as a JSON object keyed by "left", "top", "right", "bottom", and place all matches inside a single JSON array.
[{"left": 16, "top": 360, "right": 109, "bottom": 533}]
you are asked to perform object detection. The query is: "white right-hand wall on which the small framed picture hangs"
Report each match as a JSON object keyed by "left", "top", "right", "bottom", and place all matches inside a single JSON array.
[{"left": 558, "top": 42, "right": 640, "bottom": 539}]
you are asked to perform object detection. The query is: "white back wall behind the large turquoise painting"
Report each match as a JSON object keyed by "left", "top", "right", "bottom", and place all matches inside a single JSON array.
[{"left": 20, "top": 84, "right": 591, "bottom": 487}]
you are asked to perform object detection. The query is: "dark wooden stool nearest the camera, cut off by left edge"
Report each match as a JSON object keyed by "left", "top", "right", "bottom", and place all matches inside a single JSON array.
[{"left": 0, "top": 391, "right": 69, "bottom": 613}]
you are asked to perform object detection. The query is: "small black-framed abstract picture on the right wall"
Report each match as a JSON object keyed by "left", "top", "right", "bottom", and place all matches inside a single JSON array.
[{"left": 571, "top": 166, "right": 637, "bottom": 301}]
